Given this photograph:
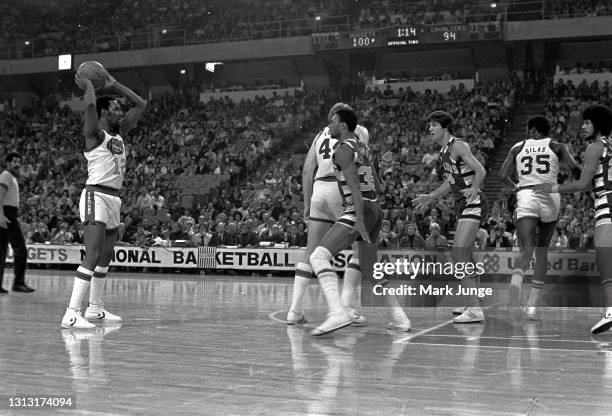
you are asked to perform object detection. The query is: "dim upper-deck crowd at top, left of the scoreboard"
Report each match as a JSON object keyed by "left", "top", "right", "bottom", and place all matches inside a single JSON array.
[{"left": 0, "top": 0, "right": 348, "bottom": 56}]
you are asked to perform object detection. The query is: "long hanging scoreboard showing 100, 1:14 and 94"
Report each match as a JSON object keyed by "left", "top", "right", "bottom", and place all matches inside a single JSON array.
[{"left": 312, "top": 22, "right": 502, "bottom": 51}]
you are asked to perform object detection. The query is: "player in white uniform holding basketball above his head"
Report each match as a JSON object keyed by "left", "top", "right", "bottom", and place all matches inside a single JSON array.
[{"left": 61, "top": 62, "right": 147, "bottom": 329}]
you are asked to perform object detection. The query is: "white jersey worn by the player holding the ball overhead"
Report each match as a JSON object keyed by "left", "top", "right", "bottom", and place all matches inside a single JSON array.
[{"left": 85, "top": 132, "right": 127, "bottom": 189}]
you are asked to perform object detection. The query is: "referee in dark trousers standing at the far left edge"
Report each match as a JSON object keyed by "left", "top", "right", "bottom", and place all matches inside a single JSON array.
[{"left": 0, "top": 152, "right": 34, "bottom": 293}]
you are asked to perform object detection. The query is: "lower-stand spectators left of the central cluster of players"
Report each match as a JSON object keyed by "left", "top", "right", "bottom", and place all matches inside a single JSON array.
[{"left": 0, "top": 83, "right": 334, "bottom": 249}]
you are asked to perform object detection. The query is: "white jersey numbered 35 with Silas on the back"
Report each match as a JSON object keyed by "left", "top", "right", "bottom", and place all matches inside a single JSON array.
[{"left": 513, "top": 138, "right": 559, "bottom": 188}]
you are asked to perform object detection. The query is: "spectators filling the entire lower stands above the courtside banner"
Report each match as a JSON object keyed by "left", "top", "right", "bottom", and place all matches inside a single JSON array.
[{"left": 0, "top": 63, "right": 612, "bottom": 254}]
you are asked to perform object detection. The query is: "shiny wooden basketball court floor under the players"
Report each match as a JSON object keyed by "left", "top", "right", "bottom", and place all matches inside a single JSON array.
[{"left": 0, "top": 270, "right": 612, "bottom": 416}]
